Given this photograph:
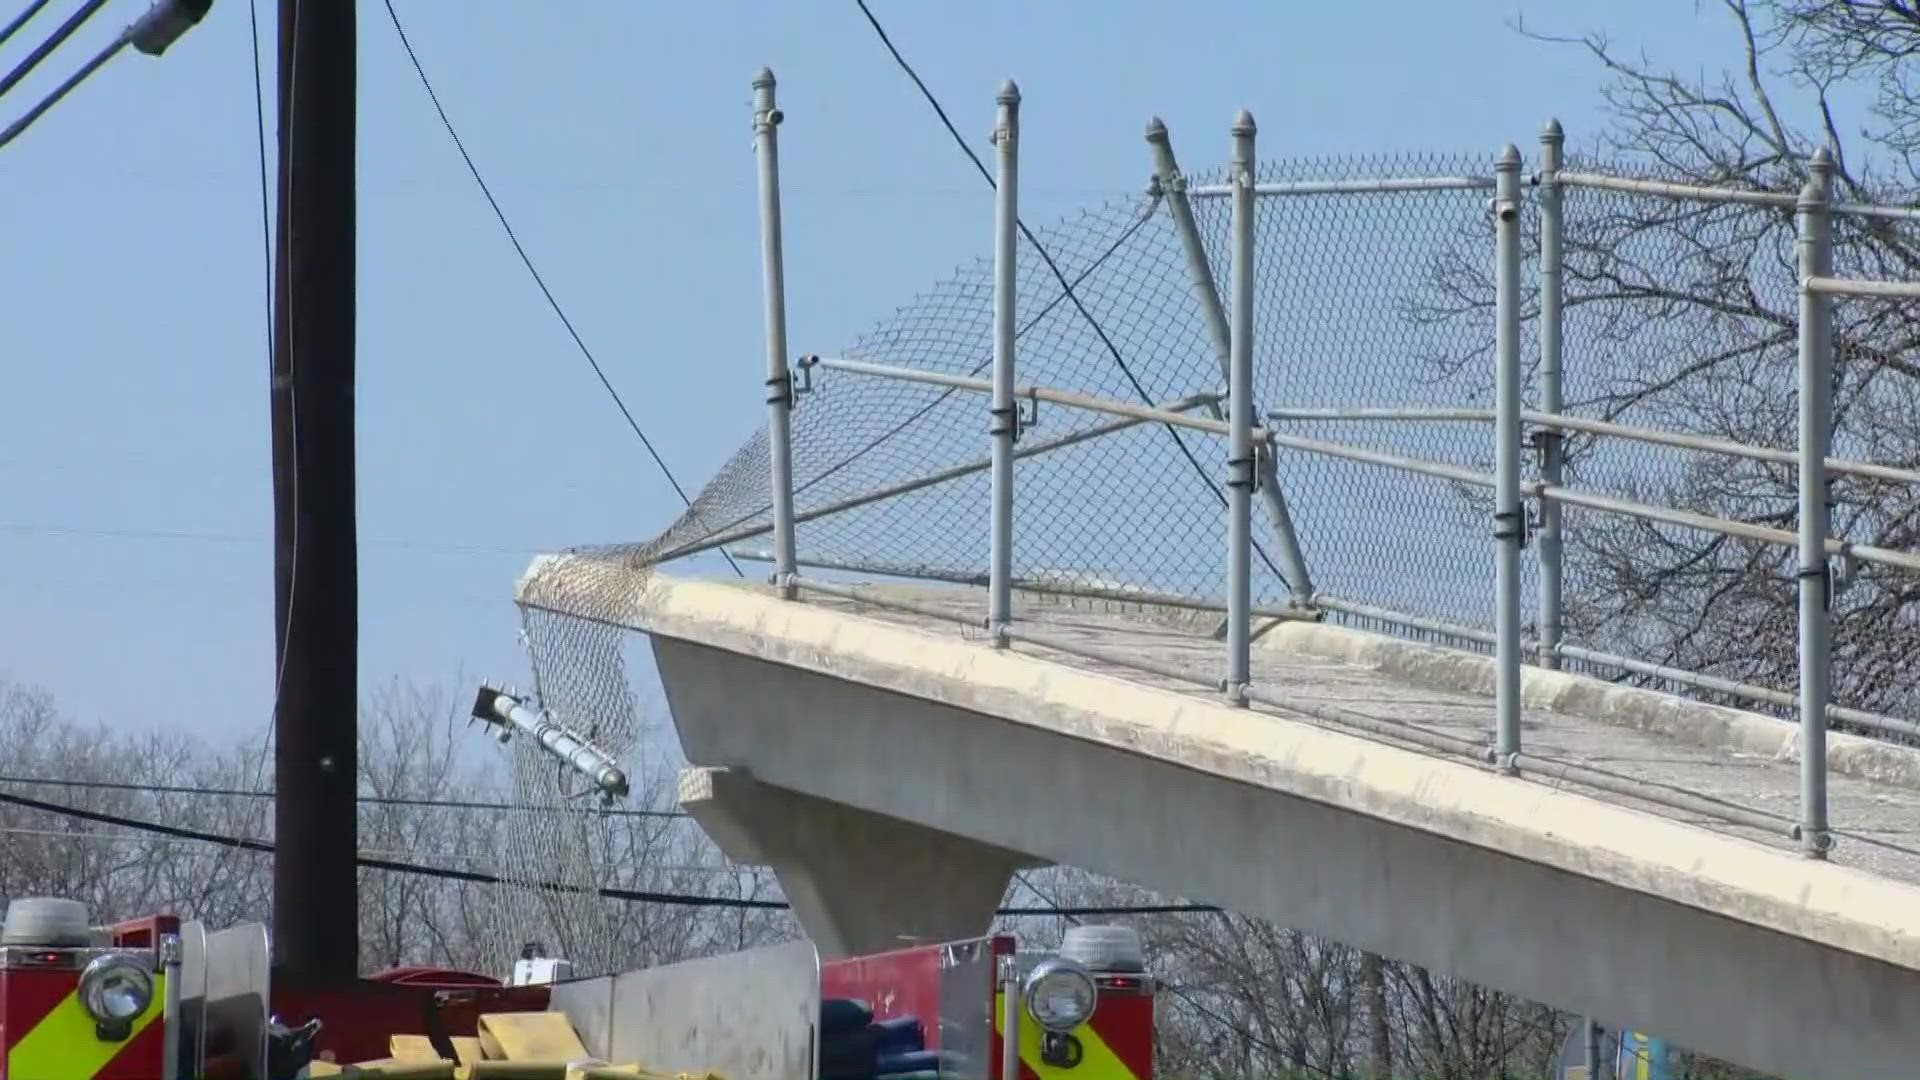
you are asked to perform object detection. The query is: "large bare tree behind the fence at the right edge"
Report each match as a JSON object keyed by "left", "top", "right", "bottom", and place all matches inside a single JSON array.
[{"left": 1413, "top": 0, "right": 1920, "bottom": 713}]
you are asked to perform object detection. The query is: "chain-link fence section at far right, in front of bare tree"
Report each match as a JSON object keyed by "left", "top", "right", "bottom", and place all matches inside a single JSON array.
[{"left": 1565, "top": 161, "right": 1920, "bottom": 734}]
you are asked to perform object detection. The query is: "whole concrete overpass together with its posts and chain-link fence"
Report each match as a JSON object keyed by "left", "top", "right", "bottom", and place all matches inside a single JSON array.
[{"left": 499, "top": 71, "right": 1920, "bottom": 1078}]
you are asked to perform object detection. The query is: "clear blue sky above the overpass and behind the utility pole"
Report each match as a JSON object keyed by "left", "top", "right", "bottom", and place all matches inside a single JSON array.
[{"left": 0, "top": 0, "right": 1730, "bottom": 740}]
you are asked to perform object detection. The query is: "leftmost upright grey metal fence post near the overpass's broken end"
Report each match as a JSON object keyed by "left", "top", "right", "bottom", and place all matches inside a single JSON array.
[{"left": 753, "top": 67, "right": 797, "bottom": 600}]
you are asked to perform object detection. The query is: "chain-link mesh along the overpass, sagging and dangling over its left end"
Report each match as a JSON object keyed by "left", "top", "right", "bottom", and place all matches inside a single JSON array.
[{"left": 503, "top": 98, "right": 1920, "bottom": 922}]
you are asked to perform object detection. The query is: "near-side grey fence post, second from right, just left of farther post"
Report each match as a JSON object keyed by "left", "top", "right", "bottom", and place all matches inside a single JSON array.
[{"left": 1494, "top": 142, "right": 1526, "bottom": 771}]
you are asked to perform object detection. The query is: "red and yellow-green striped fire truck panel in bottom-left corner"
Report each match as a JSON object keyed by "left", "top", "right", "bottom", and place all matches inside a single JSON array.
[{"left": 0, "top": 969, "right": 167, "bottom": 1080}]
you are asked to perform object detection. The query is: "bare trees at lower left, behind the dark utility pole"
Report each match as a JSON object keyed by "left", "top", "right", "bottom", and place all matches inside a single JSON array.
[{"left": 0, "top": 668, "right": 795, "bottom": 972}]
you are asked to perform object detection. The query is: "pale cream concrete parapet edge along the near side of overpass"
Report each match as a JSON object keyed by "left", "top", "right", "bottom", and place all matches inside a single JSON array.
[{"left": 514, "top": 563, "right": 1920, "bottom": 970}]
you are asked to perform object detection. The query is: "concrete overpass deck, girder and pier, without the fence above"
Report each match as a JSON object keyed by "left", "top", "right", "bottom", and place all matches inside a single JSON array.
[{"left": 522, "top": 563, "right": 1920, "bottom": 1076}]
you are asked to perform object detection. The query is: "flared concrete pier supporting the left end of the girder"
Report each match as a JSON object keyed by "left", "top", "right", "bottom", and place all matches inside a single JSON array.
[{"left": 680, "top": 769, "right": 1041, "bottom": 959}]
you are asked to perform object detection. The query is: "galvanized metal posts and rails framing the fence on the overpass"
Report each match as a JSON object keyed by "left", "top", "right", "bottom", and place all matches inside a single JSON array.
[{"left": 744, "top": 73, "right": 1920, "bottom": 857}]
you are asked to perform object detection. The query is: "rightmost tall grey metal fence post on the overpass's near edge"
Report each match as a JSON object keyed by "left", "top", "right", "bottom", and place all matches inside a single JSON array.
[{"left": 1797, "top": 146, "right": 1834, "bottom": 859}]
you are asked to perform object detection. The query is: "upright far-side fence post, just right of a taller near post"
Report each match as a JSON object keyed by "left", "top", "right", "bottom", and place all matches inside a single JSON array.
[{"left": 1534, "top": 119, "right": 1567, "bottom": 669}]
